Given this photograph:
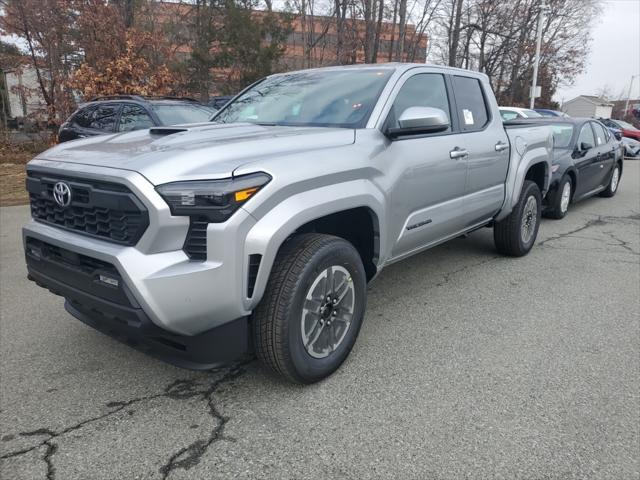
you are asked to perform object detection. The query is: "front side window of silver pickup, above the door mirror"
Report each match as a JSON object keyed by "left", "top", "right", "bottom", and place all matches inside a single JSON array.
[{"left": 385, "top": 73, "right": 451, "bottom": 132}]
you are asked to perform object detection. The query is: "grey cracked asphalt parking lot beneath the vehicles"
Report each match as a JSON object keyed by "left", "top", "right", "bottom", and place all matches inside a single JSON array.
[{"left": 0, "top": 161, "right": 640, "bottom": 480}]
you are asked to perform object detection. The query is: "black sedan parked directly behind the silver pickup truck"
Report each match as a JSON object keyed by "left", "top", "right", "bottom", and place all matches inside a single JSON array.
[{"left": 544, "top": 118, "right": 622, "bottom": 219}]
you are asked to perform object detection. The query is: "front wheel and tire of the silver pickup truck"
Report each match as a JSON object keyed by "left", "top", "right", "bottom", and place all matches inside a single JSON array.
[{"left": 252, "top": 233, "right": 366, "bottom": 383}]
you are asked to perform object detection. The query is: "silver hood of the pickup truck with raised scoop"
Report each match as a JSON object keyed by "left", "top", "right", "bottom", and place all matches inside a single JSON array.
[{"left": 36, "top": 123, "right": 355, "bottom": 185}]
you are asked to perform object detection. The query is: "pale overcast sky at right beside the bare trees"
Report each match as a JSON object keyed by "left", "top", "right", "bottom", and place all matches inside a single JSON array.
[{"left": 555, "top": 0, "right": 640, "bottom": 102}]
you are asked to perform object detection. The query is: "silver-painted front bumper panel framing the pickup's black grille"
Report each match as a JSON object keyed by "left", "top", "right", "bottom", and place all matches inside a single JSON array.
[{"left": 23, "top": 160, "right": 255, "bottom": 336}]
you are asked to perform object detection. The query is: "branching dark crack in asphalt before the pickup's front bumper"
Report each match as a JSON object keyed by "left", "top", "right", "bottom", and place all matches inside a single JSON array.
[{"left": 0, "top": 359, "right": 253, "bottom": 480}]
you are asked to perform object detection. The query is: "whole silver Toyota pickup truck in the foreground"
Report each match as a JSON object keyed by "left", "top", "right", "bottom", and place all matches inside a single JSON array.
[{"left": 23, "top": 64, "right": 553, "bottom": 383}]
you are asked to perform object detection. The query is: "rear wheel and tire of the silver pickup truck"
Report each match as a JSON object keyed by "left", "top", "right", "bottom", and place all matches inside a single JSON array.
[{"left": 493, "top": 180, "right": 542, "bottom": 257}]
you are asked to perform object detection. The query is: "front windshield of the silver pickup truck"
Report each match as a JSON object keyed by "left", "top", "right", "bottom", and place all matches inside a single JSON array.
[{"left": 213, "top": 68, "right": 393, "bottom": 128}]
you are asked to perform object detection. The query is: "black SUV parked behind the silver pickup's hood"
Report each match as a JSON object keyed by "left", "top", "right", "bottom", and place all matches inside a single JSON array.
[{"left": 58, "top": 95, "right": 215, "bottom": 142}]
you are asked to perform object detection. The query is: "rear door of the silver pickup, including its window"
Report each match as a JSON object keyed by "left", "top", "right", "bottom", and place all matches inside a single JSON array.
[{"left": 452, "top": 75, "right": 509, "bottom": 227}]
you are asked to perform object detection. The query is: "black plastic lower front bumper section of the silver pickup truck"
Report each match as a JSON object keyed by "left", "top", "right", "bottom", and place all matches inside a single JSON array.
[{"left": 25, "top": 237, "right": 249, "bottom": 369}]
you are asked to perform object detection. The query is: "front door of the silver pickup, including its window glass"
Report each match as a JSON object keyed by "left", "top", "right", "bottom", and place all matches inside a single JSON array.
[{"left": 383, "top": 73, "right": 467, "bottom": 259}]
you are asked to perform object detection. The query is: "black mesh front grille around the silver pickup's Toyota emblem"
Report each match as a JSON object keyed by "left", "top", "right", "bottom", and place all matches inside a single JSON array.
[{"left": 27, "top": 171, "right": 149, "bottom": 245}]
